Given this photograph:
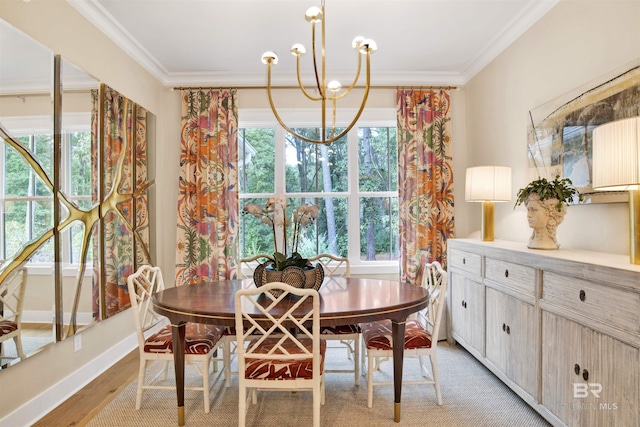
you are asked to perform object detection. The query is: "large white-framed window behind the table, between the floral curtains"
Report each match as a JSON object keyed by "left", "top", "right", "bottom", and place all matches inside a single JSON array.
[{"left": 238, "top": 110, "right": 399, "bottom": 273}]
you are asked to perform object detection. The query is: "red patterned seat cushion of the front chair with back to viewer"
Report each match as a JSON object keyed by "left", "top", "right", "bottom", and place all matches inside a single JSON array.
[{"left": 244, "top": 338, "right": 327, "bottom": 380}]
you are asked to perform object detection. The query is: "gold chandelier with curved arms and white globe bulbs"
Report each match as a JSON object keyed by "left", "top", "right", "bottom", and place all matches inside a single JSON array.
[{"left": 262, "top": 0, "right": 377, "bottom": 145}]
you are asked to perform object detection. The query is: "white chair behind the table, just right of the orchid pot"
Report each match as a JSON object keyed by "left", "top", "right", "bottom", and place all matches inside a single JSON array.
[{"left": 309, "top": 253, "right": 360, "bottom": 385}]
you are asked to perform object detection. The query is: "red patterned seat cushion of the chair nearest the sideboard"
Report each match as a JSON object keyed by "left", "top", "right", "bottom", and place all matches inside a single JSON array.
[{"left": 360, "top": 320, "right": 431, "bottom": 350}]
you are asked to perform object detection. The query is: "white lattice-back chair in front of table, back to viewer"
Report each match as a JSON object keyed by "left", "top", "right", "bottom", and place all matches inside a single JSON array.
[{"left": 235, "top": 282, "right": 327, "bottom": 427}]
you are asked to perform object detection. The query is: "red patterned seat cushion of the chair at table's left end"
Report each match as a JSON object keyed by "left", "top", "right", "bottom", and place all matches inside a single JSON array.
[{"left": 144, "top": 323, "right": 224, "bottom": 354}]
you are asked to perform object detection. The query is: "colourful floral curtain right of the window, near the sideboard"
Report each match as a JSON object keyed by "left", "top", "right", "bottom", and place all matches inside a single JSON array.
[{"left": 396, "top": 90, "right": 453, "bottom": 284}]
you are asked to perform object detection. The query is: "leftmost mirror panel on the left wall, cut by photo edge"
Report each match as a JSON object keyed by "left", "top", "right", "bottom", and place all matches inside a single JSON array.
[{"left": 0, "top": 20, "right": 56, "bottom": 366}]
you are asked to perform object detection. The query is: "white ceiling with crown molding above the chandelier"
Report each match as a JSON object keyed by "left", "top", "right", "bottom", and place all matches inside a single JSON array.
[{"left": 68, "top": 0, "right": 558, "bottom": 86}]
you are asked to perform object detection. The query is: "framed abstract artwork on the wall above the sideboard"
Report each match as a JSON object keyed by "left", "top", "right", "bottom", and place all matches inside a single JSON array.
[{"left": 527, "top": 60, "right": 640, "bottom": 203}]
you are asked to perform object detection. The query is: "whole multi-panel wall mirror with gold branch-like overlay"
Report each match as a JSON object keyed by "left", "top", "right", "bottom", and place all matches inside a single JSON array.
[{"left": 0, "top": 20, "right": 155, "bottom": 369}]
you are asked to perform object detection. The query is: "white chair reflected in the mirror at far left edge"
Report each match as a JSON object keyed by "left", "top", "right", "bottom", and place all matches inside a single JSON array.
[{"left": 0, "top": 267, "right": 27, "bottom": 359}]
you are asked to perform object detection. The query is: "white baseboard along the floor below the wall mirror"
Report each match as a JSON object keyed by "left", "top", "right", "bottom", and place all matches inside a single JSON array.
[{"left": 0, "top": 333, "right": 138, "bottom": 426}]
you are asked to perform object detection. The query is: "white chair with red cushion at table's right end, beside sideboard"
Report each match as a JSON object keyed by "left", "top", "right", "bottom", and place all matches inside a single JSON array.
[{"left": 360, "top": 262, "right": 447, "bottom": 408}]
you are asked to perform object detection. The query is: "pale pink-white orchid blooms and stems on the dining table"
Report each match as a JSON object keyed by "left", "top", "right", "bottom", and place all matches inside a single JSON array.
[{"left": 242, "top": 198, "right": 318, "bottom": 271}]
